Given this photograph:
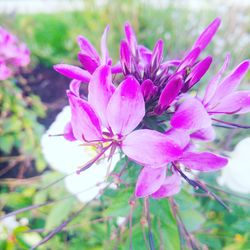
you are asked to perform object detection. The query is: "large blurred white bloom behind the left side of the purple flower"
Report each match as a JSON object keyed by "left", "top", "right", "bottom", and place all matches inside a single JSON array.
[{"left": 41, "top": 106, "right": 119, "bottom": 203}]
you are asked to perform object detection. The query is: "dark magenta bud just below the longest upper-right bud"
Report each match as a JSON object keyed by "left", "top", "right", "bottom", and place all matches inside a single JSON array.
[{"left": 186, "top": 56, "right": 212, "bottom": 89}]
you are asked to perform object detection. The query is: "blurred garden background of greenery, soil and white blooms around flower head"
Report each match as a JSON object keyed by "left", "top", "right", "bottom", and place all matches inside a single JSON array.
[{"left": 0, "top": 0, "right": 250, "bottom": 250}]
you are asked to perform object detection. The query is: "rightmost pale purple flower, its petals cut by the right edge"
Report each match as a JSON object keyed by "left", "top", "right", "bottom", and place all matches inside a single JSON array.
[{"left": 170, "top": 56, "right": 250, "bottom": 140}]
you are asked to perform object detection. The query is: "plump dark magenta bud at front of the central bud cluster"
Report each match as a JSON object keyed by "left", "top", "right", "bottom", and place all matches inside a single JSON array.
[{"left": 158, "top": 75, "right": 183, "bottom": 111}]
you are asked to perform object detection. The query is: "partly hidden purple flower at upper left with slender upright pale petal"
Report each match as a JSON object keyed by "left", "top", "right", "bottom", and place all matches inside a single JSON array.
[{"left": 54, "top": 26, "right": 121, "bottom": 83}]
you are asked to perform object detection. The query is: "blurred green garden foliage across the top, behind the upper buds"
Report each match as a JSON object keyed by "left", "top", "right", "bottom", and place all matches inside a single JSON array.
[{"left": 4, "top": 0, "right": 221, "bottom": 66}]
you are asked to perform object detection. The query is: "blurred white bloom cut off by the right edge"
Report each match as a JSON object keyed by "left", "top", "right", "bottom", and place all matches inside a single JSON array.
[{"left": 218, "top": 137, "right": 250, "bottom": 193}]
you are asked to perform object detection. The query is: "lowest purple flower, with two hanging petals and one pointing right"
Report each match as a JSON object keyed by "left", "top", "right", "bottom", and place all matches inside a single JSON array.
[{"left": 135, "top": 129, "right": 228, "bottom": 199}]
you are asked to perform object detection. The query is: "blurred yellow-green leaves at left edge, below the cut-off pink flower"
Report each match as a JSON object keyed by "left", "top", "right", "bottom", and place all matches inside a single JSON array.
[{"left": 0, "top": 80, "right": 46, "bottom": 171}]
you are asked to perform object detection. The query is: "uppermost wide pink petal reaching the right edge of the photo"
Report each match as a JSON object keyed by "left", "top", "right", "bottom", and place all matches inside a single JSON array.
[{"left": 212, "top": 61, "right": 250, "bottom": 104}]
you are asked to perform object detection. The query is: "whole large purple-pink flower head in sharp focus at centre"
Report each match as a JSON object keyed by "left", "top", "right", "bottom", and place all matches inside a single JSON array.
[{"left": 54, "top": 18, "right": 250, "bottom": 199}]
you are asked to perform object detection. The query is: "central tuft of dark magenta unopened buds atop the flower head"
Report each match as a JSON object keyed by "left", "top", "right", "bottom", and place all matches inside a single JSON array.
[{"left": 120, "top": 18, "right": 220, "bottom": 115}]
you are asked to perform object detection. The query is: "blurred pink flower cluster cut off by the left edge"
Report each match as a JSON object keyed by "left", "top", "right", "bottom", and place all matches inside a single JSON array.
[{"left": 0, "top": 27, "right": 30, "bottom": 80}]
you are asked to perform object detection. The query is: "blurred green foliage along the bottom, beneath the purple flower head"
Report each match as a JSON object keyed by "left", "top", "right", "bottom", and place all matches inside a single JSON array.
[{"left": 0, "top": 158, "right": 250, "bottom": 250}]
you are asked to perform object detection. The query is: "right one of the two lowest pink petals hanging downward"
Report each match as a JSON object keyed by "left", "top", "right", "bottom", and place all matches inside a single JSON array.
[{"left": 151, "top": 172, "right": 181, "bottom": 199}]
